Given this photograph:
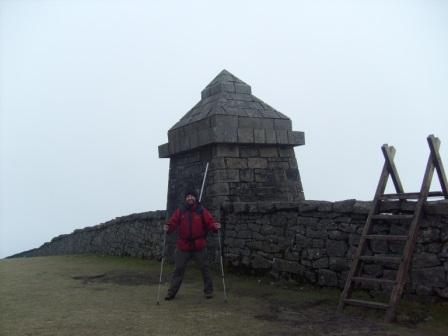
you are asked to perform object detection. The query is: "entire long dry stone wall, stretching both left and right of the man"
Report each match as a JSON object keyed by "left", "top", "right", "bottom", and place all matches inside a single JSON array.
[{"left": 14, "top": 200, "right": 448, "bottom": 298}]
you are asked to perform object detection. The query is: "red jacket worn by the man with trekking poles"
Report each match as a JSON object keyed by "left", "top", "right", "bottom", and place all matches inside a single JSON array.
[{"left": 167, "top": 205, "right": 218, "bottom": 251}]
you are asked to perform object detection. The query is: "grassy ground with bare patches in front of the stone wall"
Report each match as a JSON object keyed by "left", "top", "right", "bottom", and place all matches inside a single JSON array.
[{"left": 0, "top": 255, "right": 448, "bottom": 336}]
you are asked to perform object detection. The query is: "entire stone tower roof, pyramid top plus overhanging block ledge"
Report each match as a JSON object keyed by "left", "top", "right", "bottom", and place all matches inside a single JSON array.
[{"left": 159, "top": 70, "right": 305, "bottom": 158}]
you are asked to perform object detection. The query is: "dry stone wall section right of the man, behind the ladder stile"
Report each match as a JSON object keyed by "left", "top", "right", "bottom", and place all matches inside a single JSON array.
[{"left": 224, "top": 200, "right": 448, "bottom": 298}]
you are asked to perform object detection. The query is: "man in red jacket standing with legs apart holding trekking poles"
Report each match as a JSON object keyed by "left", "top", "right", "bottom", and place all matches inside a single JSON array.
[{"left": 164, "top": 191, "right": 221, "bottom": 300}]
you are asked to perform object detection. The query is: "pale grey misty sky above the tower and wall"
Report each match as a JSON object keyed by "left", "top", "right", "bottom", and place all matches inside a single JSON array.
[{"left": 0, "top": 0, "right": 448, "bottom": 257}]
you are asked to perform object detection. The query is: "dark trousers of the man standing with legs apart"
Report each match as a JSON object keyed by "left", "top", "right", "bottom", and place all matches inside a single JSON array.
[{"left": 168, "top": 248, "right": 213, "bottom": 297}]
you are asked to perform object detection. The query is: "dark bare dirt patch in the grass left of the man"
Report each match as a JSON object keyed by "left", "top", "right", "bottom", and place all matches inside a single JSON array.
[{"left": 72, "top": 271, "right": 159, "bottom": 286}]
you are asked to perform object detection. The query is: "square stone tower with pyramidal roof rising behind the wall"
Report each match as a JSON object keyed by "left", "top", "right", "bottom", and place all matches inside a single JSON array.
[{"left": 159, "top": 70, "right": 305, "bottom": 217}]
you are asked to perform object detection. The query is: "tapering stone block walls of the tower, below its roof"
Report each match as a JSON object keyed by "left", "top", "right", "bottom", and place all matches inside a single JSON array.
[{"left": 167, "top": 144, "right": 304, "bottom": 217}]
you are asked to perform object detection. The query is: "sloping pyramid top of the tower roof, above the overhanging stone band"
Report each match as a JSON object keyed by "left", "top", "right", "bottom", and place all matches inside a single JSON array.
[{"left": 171, "top": 70, "right": 289, "bottom": 129}]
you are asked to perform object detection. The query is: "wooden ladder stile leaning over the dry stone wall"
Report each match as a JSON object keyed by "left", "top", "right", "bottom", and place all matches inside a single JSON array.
[{"left": 338, "top": 135, "right": 448, "bottom": 322}]
